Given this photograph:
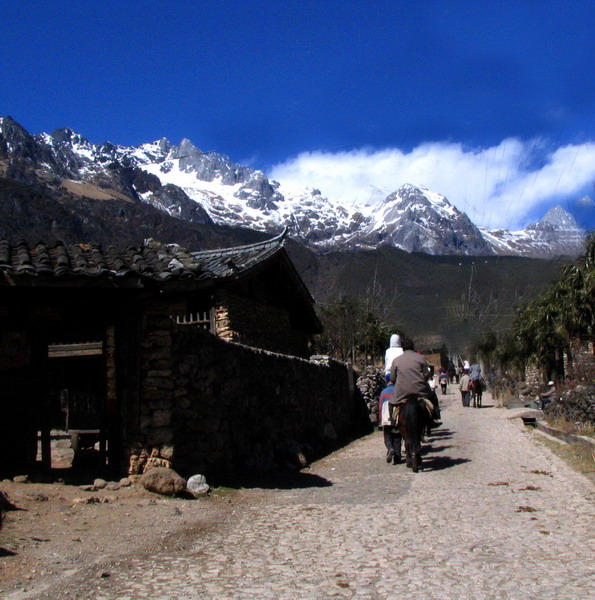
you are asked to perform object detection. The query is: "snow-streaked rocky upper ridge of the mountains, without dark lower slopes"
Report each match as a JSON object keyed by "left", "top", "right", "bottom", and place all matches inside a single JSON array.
[{"left": 0, "top": 117, "right": 585, "bottom": 257}]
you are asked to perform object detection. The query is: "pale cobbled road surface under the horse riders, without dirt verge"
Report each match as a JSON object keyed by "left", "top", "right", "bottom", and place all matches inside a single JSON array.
[{"left": 33, "top": 393, "right": 595, "bottom": 600}]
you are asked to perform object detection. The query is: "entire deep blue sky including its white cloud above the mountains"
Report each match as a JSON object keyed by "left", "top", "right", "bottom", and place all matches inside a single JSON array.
[{"left": 0, "top": 0, "right": 595, "bottom": 229}]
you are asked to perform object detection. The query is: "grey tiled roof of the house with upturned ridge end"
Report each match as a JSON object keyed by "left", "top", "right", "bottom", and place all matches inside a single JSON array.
[{"left": 0, "top": 231, "right": 286, "bottom": 282}]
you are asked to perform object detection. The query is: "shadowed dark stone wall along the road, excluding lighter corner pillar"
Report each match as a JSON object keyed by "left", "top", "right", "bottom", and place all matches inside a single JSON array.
[{"left": 172, "top": 328, "right": 369, "bottom": 473}]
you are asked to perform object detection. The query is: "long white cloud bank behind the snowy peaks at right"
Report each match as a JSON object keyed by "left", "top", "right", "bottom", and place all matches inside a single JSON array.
[{"left": 269, "top": 138, "right": 595, "bottom": 229}]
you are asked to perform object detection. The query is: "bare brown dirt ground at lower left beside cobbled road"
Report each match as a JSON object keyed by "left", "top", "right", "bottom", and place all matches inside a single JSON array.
[{"left": 0, "top": 472, "right": 242, "bottom": 598}]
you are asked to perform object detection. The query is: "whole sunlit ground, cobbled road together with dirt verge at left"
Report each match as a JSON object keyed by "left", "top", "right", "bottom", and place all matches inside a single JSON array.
[{"left": 0, "top": 394, "right": 595, "bottom": 600}]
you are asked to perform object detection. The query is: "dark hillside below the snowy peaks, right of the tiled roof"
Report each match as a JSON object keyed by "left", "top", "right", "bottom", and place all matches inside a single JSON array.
[{"left": 289, "top": 246, "right": 568, "bottom": 353}]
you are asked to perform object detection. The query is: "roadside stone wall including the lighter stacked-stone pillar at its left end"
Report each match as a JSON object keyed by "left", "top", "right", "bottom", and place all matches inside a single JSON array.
[{"left": 128, "top": 307, "right": 370, "bottom": 476}]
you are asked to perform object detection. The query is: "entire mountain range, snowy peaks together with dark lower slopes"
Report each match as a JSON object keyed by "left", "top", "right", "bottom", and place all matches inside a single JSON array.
[{"left": 0, "top": 117, "right": 585, "bottom": 351}]
